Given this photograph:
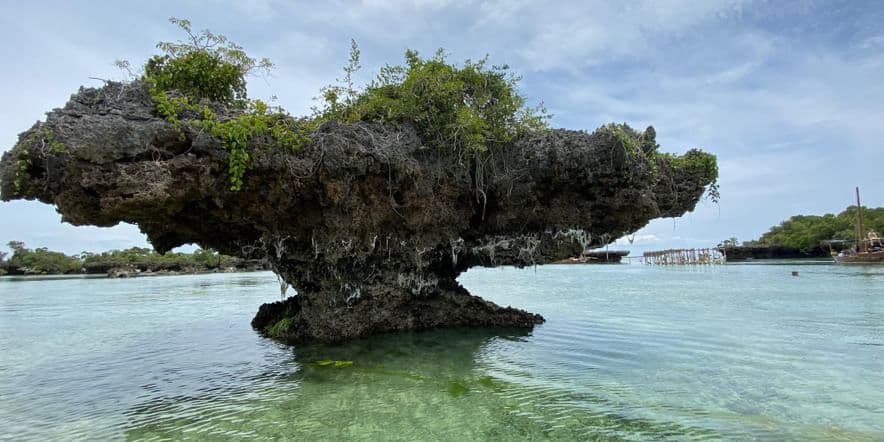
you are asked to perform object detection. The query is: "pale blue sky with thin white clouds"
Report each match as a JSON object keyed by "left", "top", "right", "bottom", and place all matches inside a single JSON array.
[{"left": 0, "top": 0, "right": 884, "bottom": 254}]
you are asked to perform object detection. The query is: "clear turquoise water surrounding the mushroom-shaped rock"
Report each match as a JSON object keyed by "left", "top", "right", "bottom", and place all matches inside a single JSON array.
[{"left": 0, "top": 263, "right": 884, "bottom": 441}]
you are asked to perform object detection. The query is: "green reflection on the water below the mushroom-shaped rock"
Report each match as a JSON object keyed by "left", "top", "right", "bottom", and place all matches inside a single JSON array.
[{"left": 126, "top": 329, "right": 720, "bottom": 440}]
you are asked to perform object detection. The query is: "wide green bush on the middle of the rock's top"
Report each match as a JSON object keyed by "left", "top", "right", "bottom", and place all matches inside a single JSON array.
[{"left": 316, "top": 42, "right": 550, "bottom": 154}]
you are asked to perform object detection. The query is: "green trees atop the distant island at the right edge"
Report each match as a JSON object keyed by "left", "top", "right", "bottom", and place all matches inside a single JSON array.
[{"left": 729, "top": 206, "right": 884, "bottom": 251}]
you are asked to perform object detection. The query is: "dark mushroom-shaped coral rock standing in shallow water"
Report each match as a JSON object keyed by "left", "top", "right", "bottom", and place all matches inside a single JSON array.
[{"left": 0, "top": 82, "right": 717, "bottom": 342}]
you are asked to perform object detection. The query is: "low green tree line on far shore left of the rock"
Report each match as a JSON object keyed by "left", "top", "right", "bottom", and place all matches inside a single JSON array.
[{"left": 0, "top": 241, "right": 265, "bottom": 275}]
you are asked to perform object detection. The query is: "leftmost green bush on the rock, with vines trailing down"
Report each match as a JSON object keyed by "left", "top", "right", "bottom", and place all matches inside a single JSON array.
[{"left": 133, "top": 17, "right": 308, "bottom": 191}]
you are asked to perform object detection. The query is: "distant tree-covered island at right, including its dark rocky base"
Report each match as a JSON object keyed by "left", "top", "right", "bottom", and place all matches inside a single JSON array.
[{"left": 718, "top": 206, "right": 884, "bottom": 261}]
